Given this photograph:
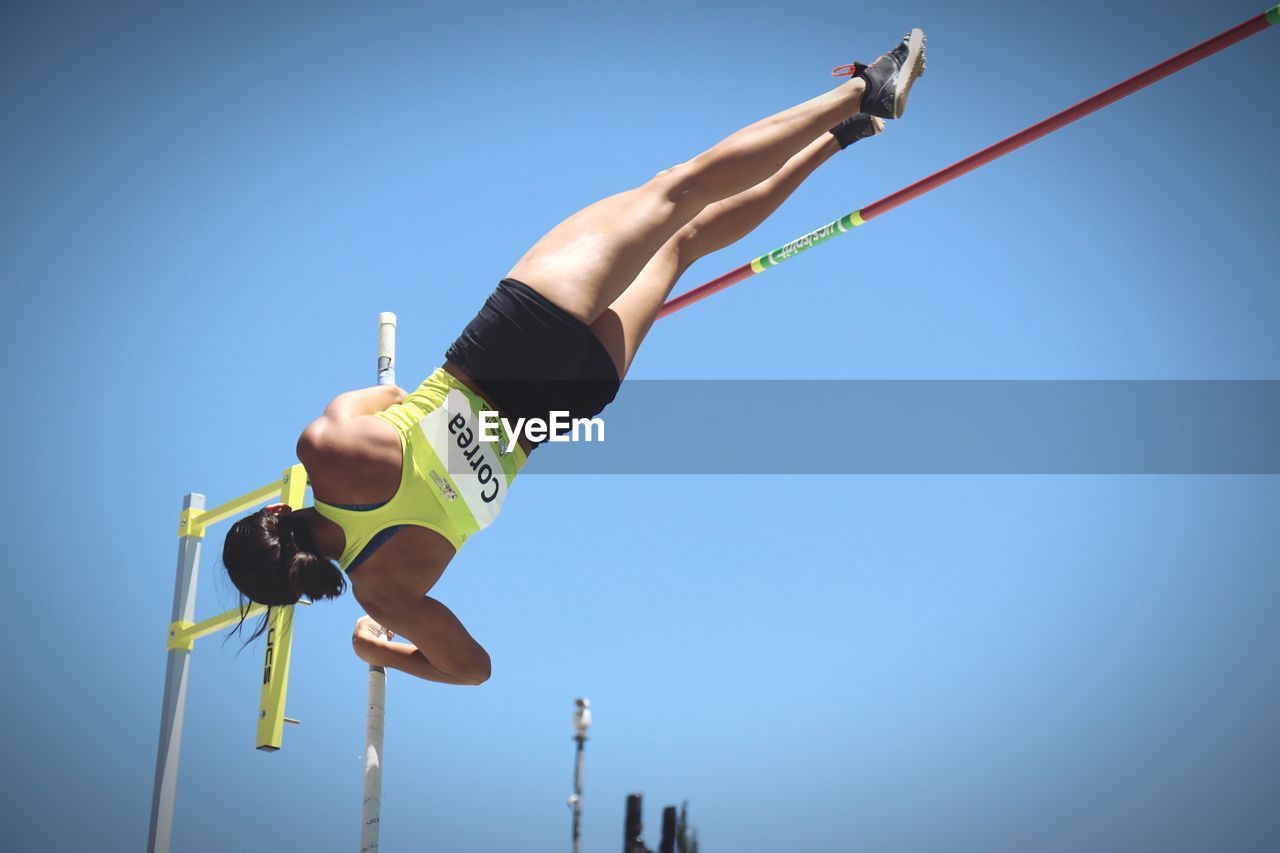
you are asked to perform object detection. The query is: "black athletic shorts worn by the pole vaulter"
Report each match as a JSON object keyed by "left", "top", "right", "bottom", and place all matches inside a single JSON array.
[{"left": 444, "top": 278, "right": 622, "bottom": 435}]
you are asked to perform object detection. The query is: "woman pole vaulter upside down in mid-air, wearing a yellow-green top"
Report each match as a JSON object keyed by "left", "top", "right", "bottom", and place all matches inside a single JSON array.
[{"left": 223, "top": 29, "right": 924, "bottom": 684}]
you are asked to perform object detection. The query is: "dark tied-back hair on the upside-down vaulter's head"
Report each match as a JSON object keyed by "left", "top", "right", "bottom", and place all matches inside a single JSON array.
[{"left": 223, "top": 508, "right": 347, "bottom": 642}]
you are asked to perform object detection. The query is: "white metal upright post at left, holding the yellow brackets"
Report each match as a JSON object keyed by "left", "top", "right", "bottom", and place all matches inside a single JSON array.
[{"left": 147, "top": 492, "right": 205, "bottom": 853}]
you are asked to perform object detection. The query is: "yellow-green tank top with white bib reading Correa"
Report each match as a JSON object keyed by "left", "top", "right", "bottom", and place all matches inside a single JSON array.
[{"left": 315, "top": 368, "right": 525, "bottom": 570}]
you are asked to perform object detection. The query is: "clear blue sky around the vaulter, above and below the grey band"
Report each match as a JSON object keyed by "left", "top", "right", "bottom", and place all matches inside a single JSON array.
[{"left": 0, "top": 0, "right": 1280, "bottom": 853}]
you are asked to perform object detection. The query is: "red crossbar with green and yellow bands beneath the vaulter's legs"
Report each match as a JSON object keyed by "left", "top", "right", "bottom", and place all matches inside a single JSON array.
[{"left": 658, "top": 5, "right": 1280, "bottom": 318}]
